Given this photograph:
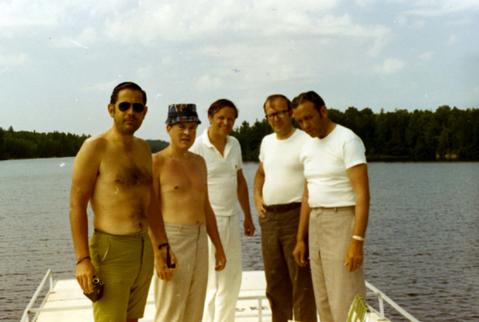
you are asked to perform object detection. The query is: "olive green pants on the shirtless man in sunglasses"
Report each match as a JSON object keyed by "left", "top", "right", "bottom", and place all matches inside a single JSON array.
[{"left": 90, "top": 230, "right": 153, "bottom": 322}]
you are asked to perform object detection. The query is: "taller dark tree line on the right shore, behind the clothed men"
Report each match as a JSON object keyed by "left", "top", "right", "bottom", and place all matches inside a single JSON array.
[{"left": 233, "top": 105, "right": 479, "bottom": 161}]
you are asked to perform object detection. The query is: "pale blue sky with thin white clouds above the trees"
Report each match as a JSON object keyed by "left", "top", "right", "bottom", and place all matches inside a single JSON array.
[{"left": 0, "top": 0, "right": 479, "bottom": 140}]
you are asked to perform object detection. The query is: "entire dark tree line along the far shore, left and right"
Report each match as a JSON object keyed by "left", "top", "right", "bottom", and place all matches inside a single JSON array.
[{"left": 0, "top": 106, "right": 479, "bottom": 161}]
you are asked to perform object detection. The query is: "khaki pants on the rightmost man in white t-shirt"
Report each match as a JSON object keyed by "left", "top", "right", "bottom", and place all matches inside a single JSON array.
[{"left": 309, "top": 207, "right": 366, "bottom": 322}]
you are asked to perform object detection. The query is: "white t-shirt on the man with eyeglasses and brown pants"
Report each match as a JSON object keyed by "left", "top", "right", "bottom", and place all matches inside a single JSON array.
[{"left": 259, "top": 129, "right": 311, "bottom": 206}]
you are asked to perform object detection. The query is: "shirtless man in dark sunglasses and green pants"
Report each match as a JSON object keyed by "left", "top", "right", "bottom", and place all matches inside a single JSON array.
[{"left": 70, "top": 82, "right": 171, "bottom": 322}]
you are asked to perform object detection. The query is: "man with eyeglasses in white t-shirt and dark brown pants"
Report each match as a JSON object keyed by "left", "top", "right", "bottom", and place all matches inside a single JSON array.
[{"left": 254, "top": 94, "right": 317, "bottom": 322}]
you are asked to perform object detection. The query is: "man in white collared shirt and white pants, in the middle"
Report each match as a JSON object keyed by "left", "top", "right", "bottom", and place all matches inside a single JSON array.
[{"left": 191, "top": 99, "right": 255, "bottom": 322}]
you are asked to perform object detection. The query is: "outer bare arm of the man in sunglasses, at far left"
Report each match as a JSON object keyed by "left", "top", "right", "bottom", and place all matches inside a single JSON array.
[{"left": 70, "top": 140, "right": 102, "bottom": 293}]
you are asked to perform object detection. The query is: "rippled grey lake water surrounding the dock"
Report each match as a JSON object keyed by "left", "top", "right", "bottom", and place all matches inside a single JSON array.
[{"left": 0, "top": 158, "right": 479, "bottom": 321}]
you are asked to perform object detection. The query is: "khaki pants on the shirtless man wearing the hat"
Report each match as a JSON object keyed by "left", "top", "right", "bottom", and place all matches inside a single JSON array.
[{"left": 155, "top": 224, "right": 208, "bottom": 322}]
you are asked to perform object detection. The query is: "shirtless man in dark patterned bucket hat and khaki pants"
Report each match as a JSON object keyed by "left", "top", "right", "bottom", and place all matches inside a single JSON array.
[{"left": 153, "top": 104, "right": 226, "bottom": 322}]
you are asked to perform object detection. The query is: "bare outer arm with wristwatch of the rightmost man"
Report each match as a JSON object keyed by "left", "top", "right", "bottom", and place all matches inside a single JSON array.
[{"left": 345, "top": 164, "right": 370, "bottom": 272}]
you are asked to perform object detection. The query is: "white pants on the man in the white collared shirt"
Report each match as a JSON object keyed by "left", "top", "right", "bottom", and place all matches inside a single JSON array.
[{"left": 203, "top": 215, "right": 242, "bottom": 322}]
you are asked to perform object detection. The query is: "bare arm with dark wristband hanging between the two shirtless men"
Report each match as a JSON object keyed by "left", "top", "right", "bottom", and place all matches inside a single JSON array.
[{"left": 148, "top": 158, "right": 176, "bottom": 280}]
